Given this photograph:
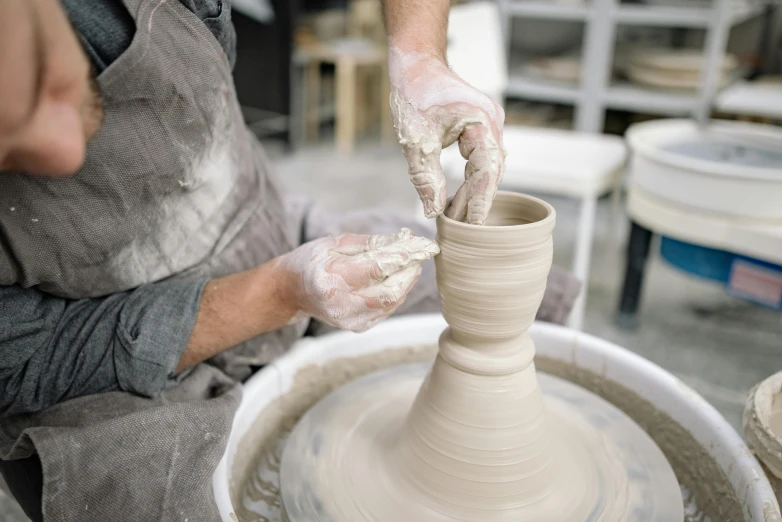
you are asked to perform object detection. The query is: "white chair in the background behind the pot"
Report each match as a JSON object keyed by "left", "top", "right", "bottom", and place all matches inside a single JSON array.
[{"left": 441, "top": 2, "right": 627, "bottom": 330}]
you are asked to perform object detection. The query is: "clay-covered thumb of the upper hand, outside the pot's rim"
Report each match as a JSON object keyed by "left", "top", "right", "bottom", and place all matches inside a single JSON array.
[{"left": 404, "top": 141, "right": 447, "bottom": 218}]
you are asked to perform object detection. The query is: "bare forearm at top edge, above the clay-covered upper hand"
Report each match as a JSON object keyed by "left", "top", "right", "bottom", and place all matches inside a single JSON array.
[{"left": 383, "top": 0, "right": 451, "bottom": 60}]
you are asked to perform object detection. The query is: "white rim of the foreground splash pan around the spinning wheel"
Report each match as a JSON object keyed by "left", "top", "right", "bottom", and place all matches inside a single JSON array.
[{"left": 213, "top": 314, "right": 779, "bottom": 522}]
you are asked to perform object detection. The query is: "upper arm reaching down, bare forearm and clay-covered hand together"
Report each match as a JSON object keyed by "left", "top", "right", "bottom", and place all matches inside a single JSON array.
[{"left": 383, "top": 0, "right": 505, "bottom": 225}]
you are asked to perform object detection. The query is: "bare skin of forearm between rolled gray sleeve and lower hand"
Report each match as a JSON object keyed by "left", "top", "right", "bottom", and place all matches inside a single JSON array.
[{"left": 176, "top": 260, "right": 296, "bottom": 372}]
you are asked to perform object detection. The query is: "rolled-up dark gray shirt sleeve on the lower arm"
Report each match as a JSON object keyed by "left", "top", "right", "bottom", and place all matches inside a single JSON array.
[{"left": 0, "top": 279, "right": 206, "bottom": 416}]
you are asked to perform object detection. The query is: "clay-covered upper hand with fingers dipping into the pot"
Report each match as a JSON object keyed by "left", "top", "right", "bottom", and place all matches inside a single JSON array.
[{"left": 389, "top": 46, "right": 505, "bottom": 224}]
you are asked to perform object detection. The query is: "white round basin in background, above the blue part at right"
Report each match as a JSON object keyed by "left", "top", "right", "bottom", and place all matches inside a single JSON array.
[{"left": 626, "top": 119, "right": 782, "bottom": 221}]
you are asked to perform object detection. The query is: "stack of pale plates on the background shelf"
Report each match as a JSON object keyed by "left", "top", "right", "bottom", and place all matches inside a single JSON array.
[{"left": 625, "top": 49, "right": 739, "bottom": 90}]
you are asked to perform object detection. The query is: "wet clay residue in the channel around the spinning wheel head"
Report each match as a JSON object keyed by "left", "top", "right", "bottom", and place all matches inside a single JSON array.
[{"left": 230, "top": 345, "right": 748, "bottom": 522}]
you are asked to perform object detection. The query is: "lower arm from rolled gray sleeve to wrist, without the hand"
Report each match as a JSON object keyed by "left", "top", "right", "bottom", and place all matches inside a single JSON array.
[{"left": 0, "top": 261, "right": 295, "bottom": 415}]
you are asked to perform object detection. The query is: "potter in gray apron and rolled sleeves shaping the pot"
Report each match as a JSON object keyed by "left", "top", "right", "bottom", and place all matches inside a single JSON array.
[{"left": 0, "top": 0, "right": 579, "bottom": 522}]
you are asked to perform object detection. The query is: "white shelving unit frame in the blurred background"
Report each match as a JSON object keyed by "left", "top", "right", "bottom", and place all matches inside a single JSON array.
[{"left": 498, "top": 0, "right": 766, "bottom": 132}]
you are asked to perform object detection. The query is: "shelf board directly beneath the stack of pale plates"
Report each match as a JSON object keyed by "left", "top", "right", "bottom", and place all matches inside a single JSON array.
[{"left": 602, "top": 83, "right": 698, "bottom": 116}]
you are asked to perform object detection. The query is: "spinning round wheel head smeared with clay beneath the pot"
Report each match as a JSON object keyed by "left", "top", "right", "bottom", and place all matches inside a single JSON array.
[{"left": 280, "top": 364, "right": 684, "bottom": 522}]
